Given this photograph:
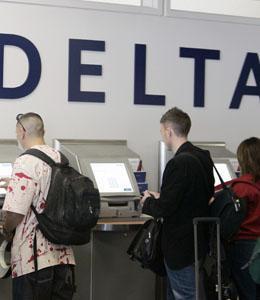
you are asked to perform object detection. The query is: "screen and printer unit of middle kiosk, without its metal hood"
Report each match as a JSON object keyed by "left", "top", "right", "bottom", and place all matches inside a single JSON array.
[{"left": 82, "top": 157, "right": 140, "bottom": 217}]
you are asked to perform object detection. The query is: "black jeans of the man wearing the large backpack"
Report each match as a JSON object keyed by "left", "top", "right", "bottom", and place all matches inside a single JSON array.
[{"left": 12, "top": 265, "right": 75, "bottom": 300}]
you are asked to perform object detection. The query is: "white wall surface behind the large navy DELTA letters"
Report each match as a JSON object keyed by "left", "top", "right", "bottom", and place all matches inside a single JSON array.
[{"left": 0, "top": 2, "right": 260, "bottom": 188}]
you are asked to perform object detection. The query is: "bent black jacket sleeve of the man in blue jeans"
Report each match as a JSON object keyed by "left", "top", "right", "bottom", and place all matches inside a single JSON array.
[{"left": 142, "top": 162, "right": 189, "bottom": 218}]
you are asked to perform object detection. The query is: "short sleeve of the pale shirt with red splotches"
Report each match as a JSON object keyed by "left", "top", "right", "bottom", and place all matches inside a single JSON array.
[{"left": 3, "top": 158, "right": 38, "bottom": 215}]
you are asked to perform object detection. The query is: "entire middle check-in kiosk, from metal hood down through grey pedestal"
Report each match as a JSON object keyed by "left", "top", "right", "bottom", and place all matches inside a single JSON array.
[{"left": 54, "top": 139, "right": 154, "bottom": 300}]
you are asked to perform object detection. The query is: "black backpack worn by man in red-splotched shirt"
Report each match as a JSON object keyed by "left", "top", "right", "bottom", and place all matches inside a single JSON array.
[{"left": 22, "top": 149, "right": 100, "bottom": 245}]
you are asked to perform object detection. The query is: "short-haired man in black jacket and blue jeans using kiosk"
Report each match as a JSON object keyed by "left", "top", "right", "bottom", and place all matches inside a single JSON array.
[{"left": 141, "top": 107, "right": 214, "bottom": 300}]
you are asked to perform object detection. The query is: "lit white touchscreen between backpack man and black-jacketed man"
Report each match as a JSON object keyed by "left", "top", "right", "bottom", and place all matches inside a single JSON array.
[{"left": 90, "top": 162, "right": 134, "bottom": 195}]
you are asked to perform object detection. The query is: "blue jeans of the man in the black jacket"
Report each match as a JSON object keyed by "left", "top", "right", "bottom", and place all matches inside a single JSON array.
[{"left": 165, "top": 262, "right": 196, "bottom": 300}]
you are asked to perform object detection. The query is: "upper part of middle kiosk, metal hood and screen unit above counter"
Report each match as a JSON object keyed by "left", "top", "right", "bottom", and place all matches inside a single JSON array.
[{"left": 54, "top": 140, "right": 140, "bottom": 218}]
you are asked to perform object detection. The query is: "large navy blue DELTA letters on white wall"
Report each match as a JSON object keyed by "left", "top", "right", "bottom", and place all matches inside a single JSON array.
[{"left": 0, "top": 34, "right": 260, "bottom": 109}]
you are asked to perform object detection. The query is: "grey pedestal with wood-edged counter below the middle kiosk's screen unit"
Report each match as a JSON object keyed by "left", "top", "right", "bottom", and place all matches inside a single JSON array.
[{"left": 73, "top": 218, "right": 156, "bottom": 300}]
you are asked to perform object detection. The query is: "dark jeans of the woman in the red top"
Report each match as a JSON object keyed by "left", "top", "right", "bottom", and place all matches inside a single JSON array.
[{"left": 227, "top": 240, "right": 260, "bottom": 300}]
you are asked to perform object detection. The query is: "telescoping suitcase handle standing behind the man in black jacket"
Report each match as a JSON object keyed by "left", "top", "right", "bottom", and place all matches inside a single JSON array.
[{"left": 193, "top": 217, "right": 222, "bottom": 300}]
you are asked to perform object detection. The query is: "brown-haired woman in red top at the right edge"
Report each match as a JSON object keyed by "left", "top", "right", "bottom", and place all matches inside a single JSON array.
[{"left": 228, "top": 137, "right": 260, "bottom": 300}]
